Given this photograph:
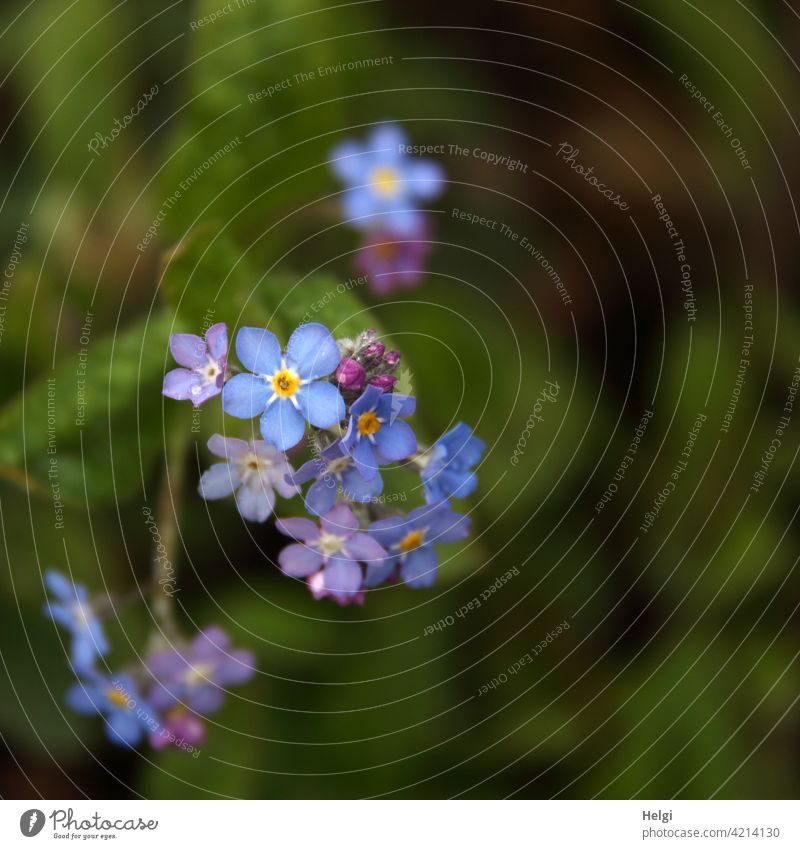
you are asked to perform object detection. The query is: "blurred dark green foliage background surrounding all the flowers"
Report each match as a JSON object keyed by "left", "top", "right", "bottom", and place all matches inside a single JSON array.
[{"left": 0, "top": 0, "right": 800, "bottom": 798}]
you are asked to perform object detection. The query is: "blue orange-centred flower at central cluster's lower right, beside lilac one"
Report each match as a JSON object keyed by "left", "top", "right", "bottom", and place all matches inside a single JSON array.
[{"left": 364, "top": 501, "right": 470, "bottom": 588}]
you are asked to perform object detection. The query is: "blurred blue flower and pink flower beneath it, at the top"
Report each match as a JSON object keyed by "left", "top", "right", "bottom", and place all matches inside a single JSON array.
[{"left": 330, "top": 124, "right": 444, "bottom": 295}]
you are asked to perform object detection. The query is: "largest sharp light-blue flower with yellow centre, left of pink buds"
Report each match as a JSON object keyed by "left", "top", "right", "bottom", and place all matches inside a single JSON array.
[{"left": 222, "top": 322, "right": 345, "bottom": 451}]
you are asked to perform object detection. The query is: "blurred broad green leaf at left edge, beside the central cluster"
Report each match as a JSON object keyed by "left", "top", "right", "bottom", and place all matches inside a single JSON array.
[{"left": 0, "top": 314, "right": 176, "bottom": 506}]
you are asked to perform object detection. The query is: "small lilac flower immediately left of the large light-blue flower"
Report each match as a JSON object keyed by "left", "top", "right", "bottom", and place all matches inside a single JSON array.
[{"left": 162, "top": 323, "right": 228, "bottom": 407}]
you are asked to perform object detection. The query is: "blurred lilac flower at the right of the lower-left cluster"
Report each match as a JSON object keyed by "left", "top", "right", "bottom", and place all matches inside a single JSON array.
[{"left": 147, "top": 626, "right": 256, "bottom": 716}]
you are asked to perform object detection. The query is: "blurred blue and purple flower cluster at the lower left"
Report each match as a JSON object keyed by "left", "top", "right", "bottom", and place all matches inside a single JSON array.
[{"left": 45, "top": 569, "right": 255, "bottom": 754}]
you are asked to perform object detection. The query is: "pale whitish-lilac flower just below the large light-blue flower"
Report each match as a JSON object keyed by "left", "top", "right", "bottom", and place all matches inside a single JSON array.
[{"left": 198, "top": 434, "right": 300, "bottom": 522}]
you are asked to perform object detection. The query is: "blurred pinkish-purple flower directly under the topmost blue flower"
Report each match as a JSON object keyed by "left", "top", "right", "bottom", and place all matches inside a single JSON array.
[{"left": 355, "top": 225, "right": 431, "bottom": 295}]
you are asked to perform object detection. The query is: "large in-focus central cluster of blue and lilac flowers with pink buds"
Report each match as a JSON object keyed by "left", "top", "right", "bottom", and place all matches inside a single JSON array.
[{"left": 164, "top": 316, "right": 485, "bottom": 604}]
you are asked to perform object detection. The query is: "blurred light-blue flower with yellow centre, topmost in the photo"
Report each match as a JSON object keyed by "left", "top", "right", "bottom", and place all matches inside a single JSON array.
[{"left": 329, "top": 124, "right": 443, "bottom": 236}]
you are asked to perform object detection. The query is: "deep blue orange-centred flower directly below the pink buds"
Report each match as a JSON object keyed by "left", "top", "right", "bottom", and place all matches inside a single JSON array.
[{"left": 342, "top": 386, "right": 417, "bottom": 480}]
